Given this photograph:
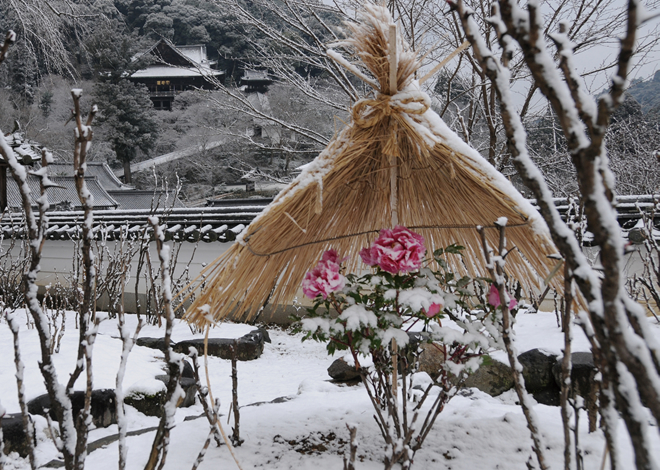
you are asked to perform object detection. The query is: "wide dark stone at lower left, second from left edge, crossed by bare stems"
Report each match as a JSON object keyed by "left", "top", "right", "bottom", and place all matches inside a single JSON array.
[{"left": 27, "top": 388, "right": 117, "bottom": 428}]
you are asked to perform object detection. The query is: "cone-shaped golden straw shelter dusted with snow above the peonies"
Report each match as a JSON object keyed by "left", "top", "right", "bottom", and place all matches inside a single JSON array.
[{"left": 186, "top": 5, "right": 560, "bottom": 325}]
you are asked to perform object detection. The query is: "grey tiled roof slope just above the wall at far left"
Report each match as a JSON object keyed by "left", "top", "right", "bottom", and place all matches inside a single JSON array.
[{"left": 7, "top": 175, "right": 119, "bottom": 211}]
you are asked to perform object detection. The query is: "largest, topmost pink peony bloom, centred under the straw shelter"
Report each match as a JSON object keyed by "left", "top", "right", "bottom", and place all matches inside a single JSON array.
[{"left": 360, "top": 225, "right": 426, "bottom": 274}]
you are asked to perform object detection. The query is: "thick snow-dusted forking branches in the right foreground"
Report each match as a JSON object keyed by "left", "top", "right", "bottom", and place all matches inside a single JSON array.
[{"left": 452, "top": 0, "right": 660, "bottom": 469}]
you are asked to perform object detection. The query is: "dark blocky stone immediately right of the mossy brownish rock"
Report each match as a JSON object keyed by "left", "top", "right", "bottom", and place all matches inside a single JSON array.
[{"left": 518, "top": 349, "right": 561, "bottom": 406}]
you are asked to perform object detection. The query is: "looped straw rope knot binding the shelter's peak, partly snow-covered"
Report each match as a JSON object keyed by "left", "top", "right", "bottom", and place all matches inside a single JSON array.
[{"left": 352, "top": 91, "right": 431, "bottom": 128}]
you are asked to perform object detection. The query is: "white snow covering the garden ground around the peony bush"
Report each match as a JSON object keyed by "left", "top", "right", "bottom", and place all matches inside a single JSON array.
[{"left": 0, "top": 312, "right": 660, "bottom": 470}]
